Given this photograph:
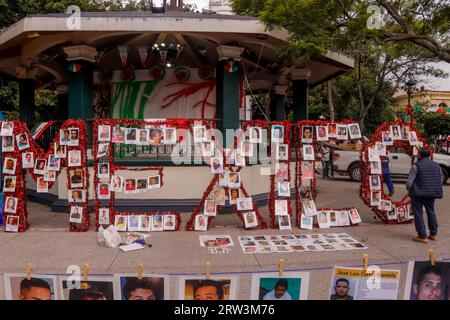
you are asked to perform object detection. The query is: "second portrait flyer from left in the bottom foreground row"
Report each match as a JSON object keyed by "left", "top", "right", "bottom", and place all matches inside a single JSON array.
[{"left": 58, "top": 277, "right": 119, "bottom": 300}]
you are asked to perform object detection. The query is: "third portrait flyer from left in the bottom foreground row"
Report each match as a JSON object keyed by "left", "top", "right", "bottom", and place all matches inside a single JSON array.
[{"left": 114, "top": 274, "right": 170, "bottom": 300}]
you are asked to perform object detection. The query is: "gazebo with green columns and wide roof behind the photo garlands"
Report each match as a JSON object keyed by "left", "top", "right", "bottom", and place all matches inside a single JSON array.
[{"left": 0, "top": 8, "right": 353, "bottom": 208}]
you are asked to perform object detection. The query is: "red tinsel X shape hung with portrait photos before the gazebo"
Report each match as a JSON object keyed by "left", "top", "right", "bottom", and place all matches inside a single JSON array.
[{"left": 185, "top": 123, "right": 267, "bottom": 231}]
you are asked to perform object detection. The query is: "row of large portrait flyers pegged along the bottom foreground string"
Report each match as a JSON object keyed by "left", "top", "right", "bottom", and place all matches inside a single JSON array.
[{"left": 3, "top": 261, "right": 450, "bottom": 301}]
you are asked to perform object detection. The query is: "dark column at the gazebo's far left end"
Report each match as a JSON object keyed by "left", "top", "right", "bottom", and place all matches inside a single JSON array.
[{"left": 19, "top": 78, "right": 36, "bottom": 128}]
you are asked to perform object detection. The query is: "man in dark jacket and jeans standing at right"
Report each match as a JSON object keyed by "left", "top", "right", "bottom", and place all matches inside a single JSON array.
[{"left": 406, "top": 148, "right": 443, "bottom": 243}]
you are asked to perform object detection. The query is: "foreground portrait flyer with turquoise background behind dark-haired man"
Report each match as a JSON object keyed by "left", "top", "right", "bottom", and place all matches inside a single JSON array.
[{"left": 251, "top": 272, "right": 309, "bottom": 301}]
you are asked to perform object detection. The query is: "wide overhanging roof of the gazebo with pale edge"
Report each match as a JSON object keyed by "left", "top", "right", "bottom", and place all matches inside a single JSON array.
[{"left": 0, "top": 12, "right": 353, "bottom": 89}]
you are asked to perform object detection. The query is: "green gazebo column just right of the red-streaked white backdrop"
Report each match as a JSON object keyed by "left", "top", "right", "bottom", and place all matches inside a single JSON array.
[{"left": 216, "top": 46, "right": 244, "bottom": 148}]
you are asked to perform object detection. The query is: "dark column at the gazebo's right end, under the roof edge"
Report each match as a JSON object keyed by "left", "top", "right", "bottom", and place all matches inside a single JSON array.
[{"left": 291, "top": 68, "right": 311, "bottom": 123}]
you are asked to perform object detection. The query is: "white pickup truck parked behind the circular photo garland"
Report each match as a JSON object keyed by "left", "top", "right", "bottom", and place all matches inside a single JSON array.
[{"left": 333, "top": 146, "right": 450, "bottom": 184}]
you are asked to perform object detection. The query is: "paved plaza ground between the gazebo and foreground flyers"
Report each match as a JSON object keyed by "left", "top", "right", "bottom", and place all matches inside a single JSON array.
[{"left": 0, "top": 178, "right": 450, "bottom": 299}]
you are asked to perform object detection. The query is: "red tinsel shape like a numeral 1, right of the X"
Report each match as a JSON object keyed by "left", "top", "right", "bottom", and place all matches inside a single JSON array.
[{"left": 243, "top": 120, "right": 292, "bottom": 228}]
